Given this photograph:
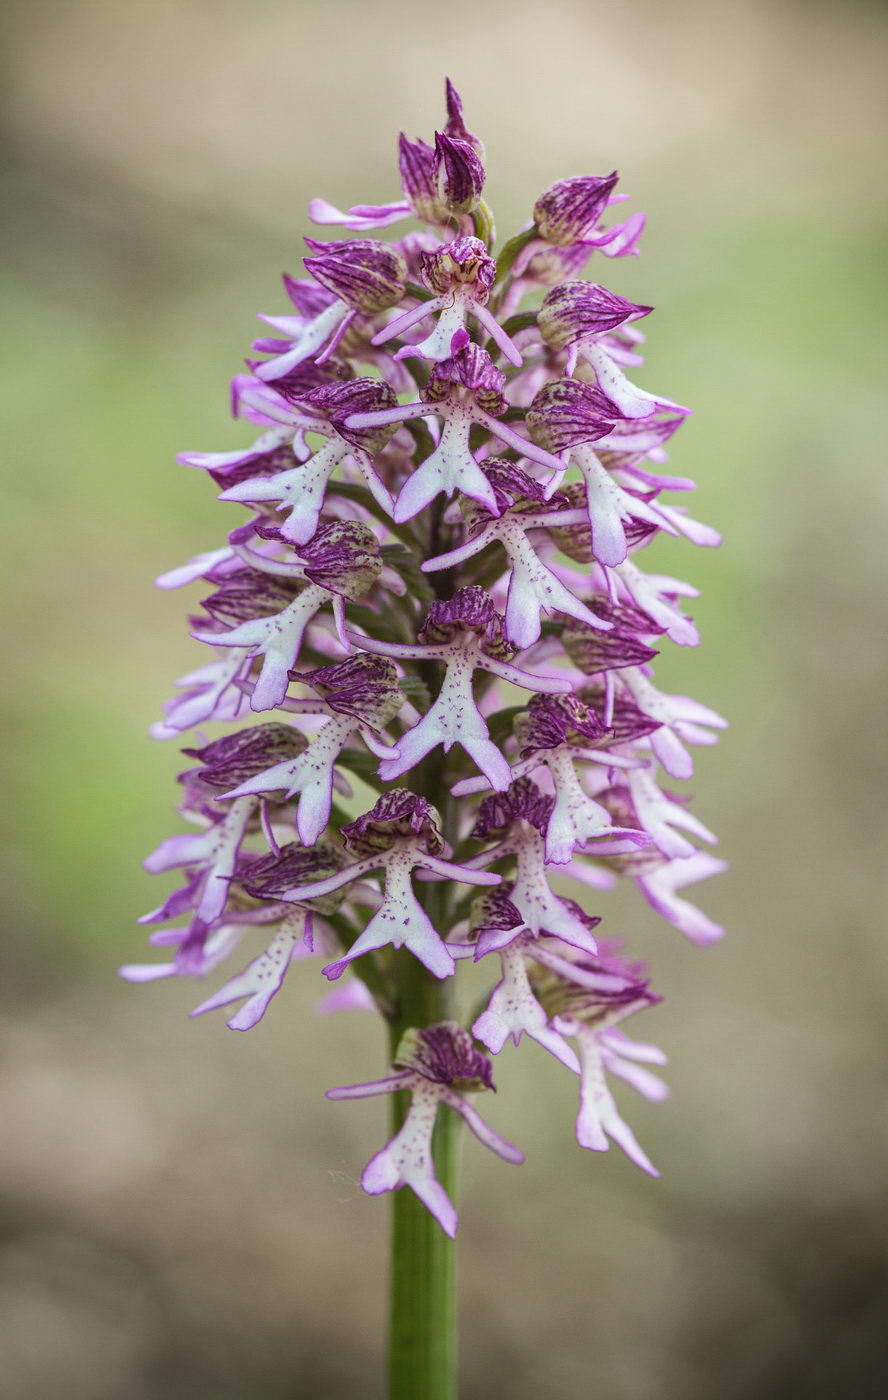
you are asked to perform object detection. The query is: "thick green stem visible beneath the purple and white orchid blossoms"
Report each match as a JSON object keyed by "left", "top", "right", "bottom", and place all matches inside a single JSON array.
[{"left": 388, "top": 958, "right": 461, "bottom": 1400}]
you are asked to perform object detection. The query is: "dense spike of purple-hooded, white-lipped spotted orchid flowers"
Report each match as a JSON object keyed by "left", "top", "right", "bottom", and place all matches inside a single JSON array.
[{"left": 133, "top": 83, "right": 724, "bottom": 1233}]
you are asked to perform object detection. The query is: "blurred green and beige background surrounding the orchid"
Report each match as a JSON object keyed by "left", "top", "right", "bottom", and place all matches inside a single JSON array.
[{"left": 0, "top": 0, "right": 888, "bottom": 1400}]
